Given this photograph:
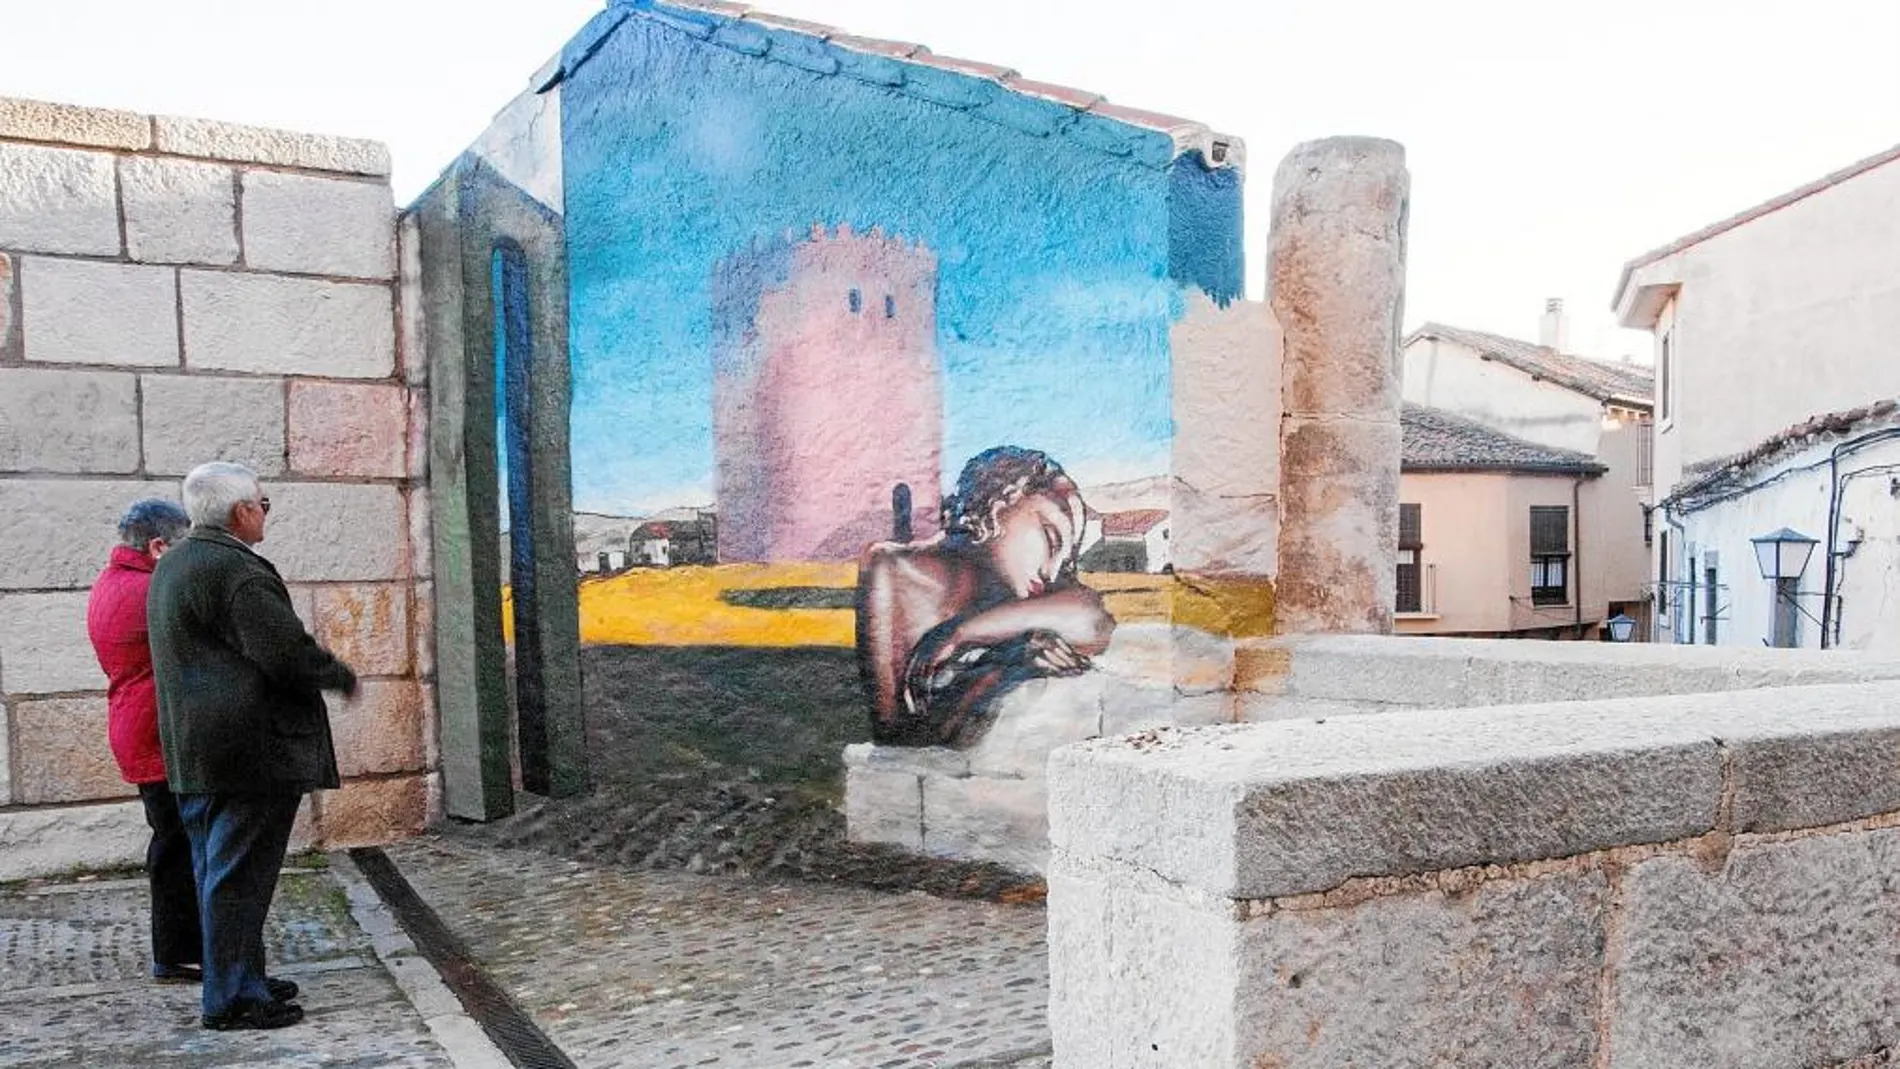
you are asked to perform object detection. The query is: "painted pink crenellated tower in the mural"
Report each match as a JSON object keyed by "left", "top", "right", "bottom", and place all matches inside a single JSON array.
[{"left": 713, "top": 226, "right": 944, "bottom": 562}]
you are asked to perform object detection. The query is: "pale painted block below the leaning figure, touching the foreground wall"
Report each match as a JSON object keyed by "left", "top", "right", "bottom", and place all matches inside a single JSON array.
[{"left": 923, "top": 777, "right": 1049, "bottom": 873}]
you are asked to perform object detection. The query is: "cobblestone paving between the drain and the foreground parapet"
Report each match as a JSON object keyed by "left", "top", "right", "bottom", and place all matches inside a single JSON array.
[{"left": 388, "top": 835, "right": 1049, "bottom": 1069}]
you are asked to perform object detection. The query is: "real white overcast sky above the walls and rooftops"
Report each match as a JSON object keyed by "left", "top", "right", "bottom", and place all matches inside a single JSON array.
[{"left": 0, "top": 0, "right": 1900, "bottom": 359}]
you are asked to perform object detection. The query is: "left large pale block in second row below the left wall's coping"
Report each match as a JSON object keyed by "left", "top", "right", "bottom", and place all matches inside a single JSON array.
[{"left": 19, "top": 256, "right": 179, "bottom": 366}]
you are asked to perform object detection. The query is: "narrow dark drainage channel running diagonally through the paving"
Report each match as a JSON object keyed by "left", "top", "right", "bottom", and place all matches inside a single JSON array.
[{"left": 350, "top": 847, "right": 578, "bottom": 1069}]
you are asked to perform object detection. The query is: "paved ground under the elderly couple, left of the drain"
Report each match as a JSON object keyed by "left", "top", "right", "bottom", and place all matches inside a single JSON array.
[{"left": 0, "top": 870, "right": 452, "bottom": 1069}]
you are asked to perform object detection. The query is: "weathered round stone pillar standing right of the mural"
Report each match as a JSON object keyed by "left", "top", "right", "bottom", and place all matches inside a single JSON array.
[{"left": 1267, "top": 137, "right": 1410, "bottom": 634}]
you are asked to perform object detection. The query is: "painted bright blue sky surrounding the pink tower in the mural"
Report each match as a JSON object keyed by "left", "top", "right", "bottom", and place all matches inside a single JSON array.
[{"left": 562, "top": 17, "right": 1180, "bottom": 513}]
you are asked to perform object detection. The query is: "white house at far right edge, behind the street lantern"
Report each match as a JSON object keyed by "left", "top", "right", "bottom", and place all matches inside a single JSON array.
[{"left": 1613, "top": 137, "right": 1900, "bottom": 651}]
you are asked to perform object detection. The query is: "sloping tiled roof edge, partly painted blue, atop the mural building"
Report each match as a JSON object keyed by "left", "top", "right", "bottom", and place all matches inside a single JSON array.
[{"left": 534, "top": 0, "right": 1246, "bottom": 167}]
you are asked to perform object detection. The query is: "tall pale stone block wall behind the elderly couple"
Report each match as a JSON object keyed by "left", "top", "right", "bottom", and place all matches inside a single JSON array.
[{"left": 0, "top": 99, "right": 437, "bottom": 879}]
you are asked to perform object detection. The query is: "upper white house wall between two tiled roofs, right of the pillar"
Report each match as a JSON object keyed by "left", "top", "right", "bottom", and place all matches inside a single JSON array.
[{"left": 1404, "top": 338, "right": 1604, "bottom": 456}]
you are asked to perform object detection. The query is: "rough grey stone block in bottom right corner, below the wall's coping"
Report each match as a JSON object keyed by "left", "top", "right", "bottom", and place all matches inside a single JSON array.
[{"left": 1607, "top": 830, "right": 1900, "bottom": 1069}]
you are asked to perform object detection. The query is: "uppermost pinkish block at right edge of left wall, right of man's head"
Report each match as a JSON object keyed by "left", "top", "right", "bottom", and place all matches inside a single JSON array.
[{"left": 291, "top": 382, "right": 409, "bottom": 478}]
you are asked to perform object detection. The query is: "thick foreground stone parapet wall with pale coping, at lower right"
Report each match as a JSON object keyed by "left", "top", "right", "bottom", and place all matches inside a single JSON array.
[{"left": 1049, "top": 682, "right": 1900, "bottom": 1069}]
